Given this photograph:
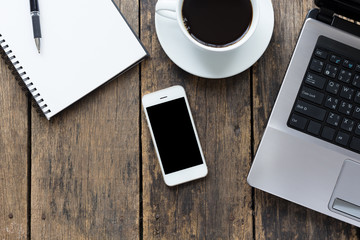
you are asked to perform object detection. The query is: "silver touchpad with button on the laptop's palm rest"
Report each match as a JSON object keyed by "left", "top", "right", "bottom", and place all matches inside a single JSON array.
[{"left": 329, "top": 160, "right": 360, "bottom": 221}]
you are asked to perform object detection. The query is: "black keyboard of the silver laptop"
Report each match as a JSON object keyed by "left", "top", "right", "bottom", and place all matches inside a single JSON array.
[{"left": 287, "top": 36, "right": 360, "bottom": 153}]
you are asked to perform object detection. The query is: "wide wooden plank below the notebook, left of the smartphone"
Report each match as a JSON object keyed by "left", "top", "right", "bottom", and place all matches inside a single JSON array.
[{"left": 31, "top": 0, "right": 140, "bottom": 239}]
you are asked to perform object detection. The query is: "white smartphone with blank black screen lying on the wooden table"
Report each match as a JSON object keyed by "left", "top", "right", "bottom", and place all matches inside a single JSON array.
[{"left": 142, "top": 86, "right": 208, "bottom": 186}]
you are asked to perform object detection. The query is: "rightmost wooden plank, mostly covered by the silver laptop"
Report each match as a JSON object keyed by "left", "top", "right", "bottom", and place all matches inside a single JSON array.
[{"left": 253, "top": 0, "right": 360, "bottom": 239}]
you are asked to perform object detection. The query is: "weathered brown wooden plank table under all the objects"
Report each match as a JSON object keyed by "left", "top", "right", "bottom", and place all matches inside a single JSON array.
[{"left": 0, "top": 0, "right": 360, "bottom": 240}]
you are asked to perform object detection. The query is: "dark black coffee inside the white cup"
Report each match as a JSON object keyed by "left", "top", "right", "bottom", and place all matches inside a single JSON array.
[{"left": 182, "top": 0, "right": 253, "bottom": 47}]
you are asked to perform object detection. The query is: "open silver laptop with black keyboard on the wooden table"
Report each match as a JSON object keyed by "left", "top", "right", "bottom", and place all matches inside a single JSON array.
[{"left": 247, "top": 0, "right": 360, "bottom": 227}]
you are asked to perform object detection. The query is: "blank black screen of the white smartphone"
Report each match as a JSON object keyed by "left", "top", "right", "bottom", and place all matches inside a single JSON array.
[{"left": 146, "top": 97, "right": 203, "bottom": 174}]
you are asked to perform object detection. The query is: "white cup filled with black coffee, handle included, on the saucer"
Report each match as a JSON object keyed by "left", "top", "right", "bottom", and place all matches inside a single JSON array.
[{"left": 156, "top": 0, "right": 259, "bottom": 52}]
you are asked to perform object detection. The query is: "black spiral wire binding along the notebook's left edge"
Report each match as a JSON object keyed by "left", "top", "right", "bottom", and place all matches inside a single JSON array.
[{"left": 0, "top": 33, "right": 51, "bottom": 116}]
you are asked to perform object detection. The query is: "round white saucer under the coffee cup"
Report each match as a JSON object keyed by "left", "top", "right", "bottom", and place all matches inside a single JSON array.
[{"left": 155, "top": 0, "right": 274, "bottom": 78}]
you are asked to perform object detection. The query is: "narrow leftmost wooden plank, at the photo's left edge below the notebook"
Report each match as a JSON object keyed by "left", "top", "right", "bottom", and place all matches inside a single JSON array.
[{"left": 0, "top": 49, "right": 28, "bottom": 239}]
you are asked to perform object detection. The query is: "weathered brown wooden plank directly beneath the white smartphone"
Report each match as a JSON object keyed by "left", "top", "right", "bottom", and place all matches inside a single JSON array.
[{"left": 140, "top": 0, "right": 253, "bottom": 239}]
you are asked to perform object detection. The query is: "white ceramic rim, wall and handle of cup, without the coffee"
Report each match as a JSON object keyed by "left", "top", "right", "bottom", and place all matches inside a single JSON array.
[{"left": 155, "top": 0, "right": 259, "bottom": 52}]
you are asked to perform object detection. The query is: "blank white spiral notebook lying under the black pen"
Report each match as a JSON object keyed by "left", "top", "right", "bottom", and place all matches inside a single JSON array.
[{"left": 0, "top": 0, "right": 147, "bottom": 119}]
